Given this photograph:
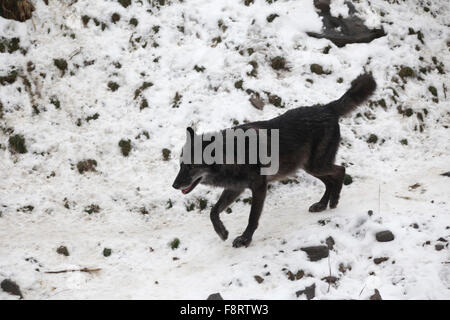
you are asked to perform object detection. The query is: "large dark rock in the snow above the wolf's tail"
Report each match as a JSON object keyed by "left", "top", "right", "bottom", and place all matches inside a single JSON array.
[{"left": 307, "top": 0, "right": 386, "bottom": 47}]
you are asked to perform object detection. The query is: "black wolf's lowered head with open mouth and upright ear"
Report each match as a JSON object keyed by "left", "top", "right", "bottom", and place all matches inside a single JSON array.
[{"left": 172, "top": 127, "right": 211, "bottom": 194}]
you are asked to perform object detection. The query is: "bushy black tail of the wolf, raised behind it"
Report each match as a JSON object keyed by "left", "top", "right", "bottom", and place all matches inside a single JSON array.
[{"left": 330, "top": 73, "right": 377, "bottom": 116}]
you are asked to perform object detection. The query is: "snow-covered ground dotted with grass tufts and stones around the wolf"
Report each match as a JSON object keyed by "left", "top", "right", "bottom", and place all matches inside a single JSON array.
[{"left": 0, "top": 0, "right": 450, "bottom": 299}]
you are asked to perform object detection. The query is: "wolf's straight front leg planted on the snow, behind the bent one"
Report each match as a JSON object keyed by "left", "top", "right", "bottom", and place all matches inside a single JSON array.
[{"left": 233, "top": 176, "right": 267, "bottom": 248}]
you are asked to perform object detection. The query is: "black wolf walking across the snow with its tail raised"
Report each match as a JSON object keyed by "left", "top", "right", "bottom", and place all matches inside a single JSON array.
[{"left": 173, "top": 74, "right": 376, "bottom": 247}]
